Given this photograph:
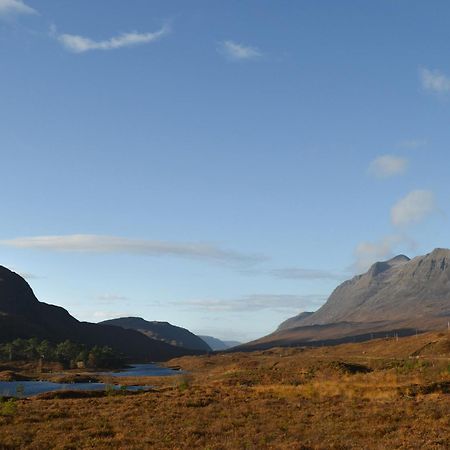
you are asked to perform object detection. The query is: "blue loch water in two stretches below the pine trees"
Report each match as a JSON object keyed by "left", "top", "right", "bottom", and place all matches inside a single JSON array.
[{"left": 0, "top": 364, "right": 181, "bottom": 397}]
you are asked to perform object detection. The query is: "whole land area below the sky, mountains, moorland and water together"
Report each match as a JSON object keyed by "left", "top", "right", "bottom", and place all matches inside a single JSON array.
[{"left": 0, "top": 249, "right": 450, "bottom": 450}]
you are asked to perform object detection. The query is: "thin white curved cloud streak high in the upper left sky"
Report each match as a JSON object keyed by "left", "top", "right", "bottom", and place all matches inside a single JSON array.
[{"left": 57, "top": 26, "right": 170, "bottom": 53}]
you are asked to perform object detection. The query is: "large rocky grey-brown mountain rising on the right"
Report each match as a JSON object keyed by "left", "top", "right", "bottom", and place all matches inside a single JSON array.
[{"left": 238, "top": 248, "right": 450, "bottom": 349}]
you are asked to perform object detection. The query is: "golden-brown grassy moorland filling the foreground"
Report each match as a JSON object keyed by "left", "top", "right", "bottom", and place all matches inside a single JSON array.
[{"left": 0, "top": 333, "right": 450, "bottom": 449}]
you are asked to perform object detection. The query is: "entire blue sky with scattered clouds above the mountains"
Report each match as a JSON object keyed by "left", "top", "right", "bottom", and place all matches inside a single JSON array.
[{"left": 0, "top": 0, "right": 450, "bottom": 341}]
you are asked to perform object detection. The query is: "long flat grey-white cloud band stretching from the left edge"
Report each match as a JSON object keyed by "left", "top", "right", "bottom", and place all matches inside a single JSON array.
[{"left": 0, "top": 234, "right": 266, "bottom": 264}]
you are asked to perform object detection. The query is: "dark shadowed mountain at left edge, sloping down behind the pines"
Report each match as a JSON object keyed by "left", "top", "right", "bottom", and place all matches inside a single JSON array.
[{"left": 0, "top": 266, "right": 198, "bottom": 361}]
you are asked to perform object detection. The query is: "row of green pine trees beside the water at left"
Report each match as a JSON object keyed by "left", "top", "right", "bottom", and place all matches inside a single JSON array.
[{"left": 0, "top": 338, "right": 125, "bottom": 368}]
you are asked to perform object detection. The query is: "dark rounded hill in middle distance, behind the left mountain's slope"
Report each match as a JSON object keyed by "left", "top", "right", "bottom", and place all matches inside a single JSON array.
[{"left": 100, "top": 317, "right": 212, "bottom": 352}]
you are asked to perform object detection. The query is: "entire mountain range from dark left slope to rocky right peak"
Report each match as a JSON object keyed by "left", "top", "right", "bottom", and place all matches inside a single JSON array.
[{"left": 0, "top": 248, "right": 450, "bottom": 361}]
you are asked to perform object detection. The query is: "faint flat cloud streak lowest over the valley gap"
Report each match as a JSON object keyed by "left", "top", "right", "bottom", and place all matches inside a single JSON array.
[{"left": 169, "top": 294, "right": 326, "bottom": 312}]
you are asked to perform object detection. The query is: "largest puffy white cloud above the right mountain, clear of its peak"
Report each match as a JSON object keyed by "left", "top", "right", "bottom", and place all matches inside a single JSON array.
[{"left": 391, "top": 190, "right": 437, "bottom": 227}]
